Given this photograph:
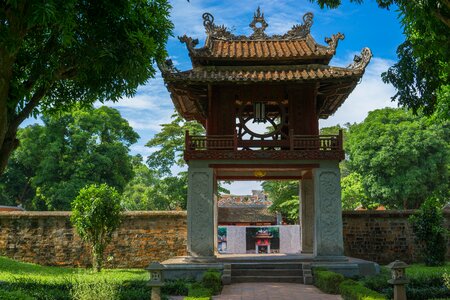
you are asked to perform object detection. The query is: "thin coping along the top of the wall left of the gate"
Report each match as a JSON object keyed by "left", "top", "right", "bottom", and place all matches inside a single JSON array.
[{"left": 0, "top": 211, "right": 187, "bottom": 218}]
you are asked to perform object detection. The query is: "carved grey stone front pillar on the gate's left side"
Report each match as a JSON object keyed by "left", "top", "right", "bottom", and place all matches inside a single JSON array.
[{"left": 187, "top": 166, "right": 216, "bottom": 259}]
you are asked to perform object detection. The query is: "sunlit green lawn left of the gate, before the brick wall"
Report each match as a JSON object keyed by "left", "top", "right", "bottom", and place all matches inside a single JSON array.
[{"left": 0, "top": 257, "right": 150, "bottom": 300}]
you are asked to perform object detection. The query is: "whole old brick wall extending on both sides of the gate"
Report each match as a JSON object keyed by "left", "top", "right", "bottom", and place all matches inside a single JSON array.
[{"left": 0, "top": 211, "right": 450, "bottom": 268}]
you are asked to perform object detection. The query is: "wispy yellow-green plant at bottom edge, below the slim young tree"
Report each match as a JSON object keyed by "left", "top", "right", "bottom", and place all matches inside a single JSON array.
[{"left": 70, "top": 277, "right": 118, "bottom": 300}]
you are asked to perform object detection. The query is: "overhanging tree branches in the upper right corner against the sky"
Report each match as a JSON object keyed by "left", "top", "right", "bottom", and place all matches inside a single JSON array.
[{"left": 311, "top": 0, "right": 450, "bottom": 119}]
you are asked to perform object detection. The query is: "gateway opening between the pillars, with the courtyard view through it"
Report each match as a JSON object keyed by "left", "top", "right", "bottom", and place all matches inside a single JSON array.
[{"left": 215, "top": 176, "right": 301, "bottom": 256}]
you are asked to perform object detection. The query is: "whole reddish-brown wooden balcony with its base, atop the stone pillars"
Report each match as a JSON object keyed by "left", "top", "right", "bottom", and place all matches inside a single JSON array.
[{"left": 184, "top": 131, "right": 344, "bottom": 161}]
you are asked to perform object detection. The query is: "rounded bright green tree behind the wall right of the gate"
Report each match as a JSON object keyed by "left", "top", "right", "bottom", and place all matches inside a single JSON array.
[{"left": 347, "top": 108, "right": 450, "bottom": 209}]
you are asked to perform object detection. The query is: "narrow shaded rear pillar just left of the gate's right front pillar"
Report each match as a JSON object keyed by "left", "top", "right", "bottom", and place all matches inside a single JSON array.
[{"left": 300, "top": 179, "right": 314, "bottom": 254}]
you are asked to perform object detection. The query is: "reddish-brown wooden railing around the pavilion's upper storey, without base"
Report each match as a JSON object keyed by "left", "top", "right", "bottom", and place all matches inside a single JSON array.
[{"left": 185, "top": 131, "right": 343, "bottom": 151}]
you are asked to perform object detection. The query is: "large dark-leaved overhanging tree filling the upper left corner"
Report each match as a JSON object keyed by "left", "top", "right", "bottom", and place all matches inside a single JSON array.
[{"left": 0, "top": 0, "right": 173, "bottom": 174}]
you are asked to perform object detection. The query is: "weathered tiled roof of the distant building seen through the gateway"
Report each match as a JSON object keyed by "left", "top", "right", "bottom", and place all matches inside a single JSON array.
[{"left": 218, "top": 206, "right": 277, "bottom": 224}]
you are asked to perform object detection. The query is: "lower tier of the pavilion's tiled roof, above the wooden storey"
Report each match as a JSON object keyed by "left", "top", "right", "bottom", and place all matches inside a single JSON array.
[{"left": 164, "top": 65, "right": 364, "bottom": 82}]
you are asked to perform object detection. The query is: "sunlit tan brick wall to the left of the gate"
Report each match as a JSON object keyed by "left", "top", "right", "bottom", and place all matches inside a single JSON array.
[{"left": 0, "top": 212, "right": 187, "bottom": 268}]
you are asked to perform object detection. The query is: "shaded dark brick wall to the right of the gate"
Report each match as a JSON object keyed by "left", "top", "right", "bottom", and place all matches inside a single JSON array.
[{"left": 342, "top": 210, "right": 450, "bottom": 264}]
